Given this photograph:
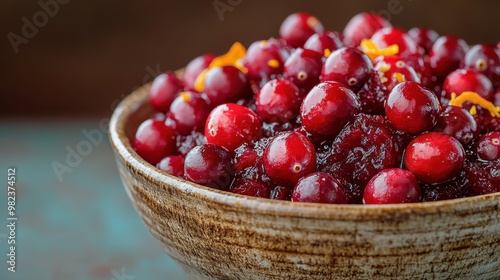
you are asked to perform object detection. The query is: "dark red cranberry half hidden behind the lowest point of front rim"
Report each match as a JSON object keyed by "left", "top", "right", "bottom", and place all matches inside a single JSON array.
[{"left": 292, "top": 172, "right": 347, "bottom": 204}]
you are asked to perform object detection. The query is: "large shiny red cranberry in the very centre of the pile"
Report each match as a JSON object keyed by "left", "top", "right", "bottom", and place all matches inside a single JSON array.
[{"left": 300, "top": 82, "right": 361, "bottom": 137}]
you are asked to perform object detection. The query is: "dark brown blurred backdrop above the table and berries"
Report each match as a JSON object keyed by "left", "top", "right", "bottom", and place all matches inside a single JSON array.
[{"left": 0, "top": 0, "right": 500, "bottom": 118}]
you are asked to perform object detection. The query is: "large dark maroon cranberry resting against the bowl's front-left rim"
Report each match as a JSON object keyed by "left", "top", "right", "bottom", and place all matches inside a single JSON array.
[{"left": 184, "top": 144, "right": 234, "bottom": 190}]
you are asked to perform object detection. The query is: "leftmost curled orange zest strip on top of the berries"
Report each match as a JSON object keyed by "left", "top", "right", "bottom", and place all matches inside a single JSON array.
[{"left": 194, "top": 42, "right": 248, "bottom": 92}]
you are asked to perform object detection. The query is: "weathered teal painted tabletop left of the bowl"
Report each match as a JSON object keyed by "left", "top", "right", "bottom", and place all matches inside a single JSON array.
[{"left": 0, "top": 120, "right": 186, "bottom": 280}]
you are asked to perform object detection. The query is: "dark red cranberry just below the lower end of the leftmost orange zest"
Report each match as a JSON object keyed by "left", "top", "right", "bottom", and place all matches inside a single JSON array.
[{"left": 167, "top": 92, "right": 210, "bottom": 135}]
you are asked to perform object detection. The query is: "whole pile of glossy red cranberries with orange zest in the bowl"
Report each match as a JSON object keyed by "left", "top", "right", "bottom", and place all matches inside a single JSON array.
[{"left": 133, "top": 13, "right": 500, "bottom": 204}]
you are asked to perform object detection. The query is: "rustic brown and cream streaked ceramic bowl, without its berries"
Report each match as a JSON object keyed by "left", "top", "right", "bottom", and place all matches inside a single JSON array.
[{"left": 110, "top": 83, "right": 500, "bottom": 279}]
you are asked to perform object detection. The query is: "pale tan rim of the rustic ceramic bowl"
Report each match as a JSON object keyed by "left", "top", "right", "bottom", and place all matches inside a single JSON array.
[{"left": 109, "top": 84, "right": 500, "bottom": 218}]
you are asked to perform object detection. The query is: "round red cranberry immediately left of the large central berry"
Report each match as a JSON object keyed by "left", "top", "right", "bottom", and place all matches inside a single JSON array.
[{"left": 255, "top": 79, "right": 303, "bottom": 123}]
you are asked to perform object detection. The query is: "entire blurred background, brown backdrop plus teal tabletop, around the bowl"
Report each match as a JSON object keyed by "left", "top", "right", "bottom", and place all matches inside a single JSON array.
[{"left": 0, "top": 0, "right": 500, "bottom": 280}]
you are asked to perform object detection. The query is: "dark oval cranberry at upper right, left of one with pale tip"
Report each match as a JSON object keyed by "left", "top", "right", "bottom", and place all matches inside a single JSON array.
[{"left": 429, "top": 35, "right": 469, "bottom": 78}]
